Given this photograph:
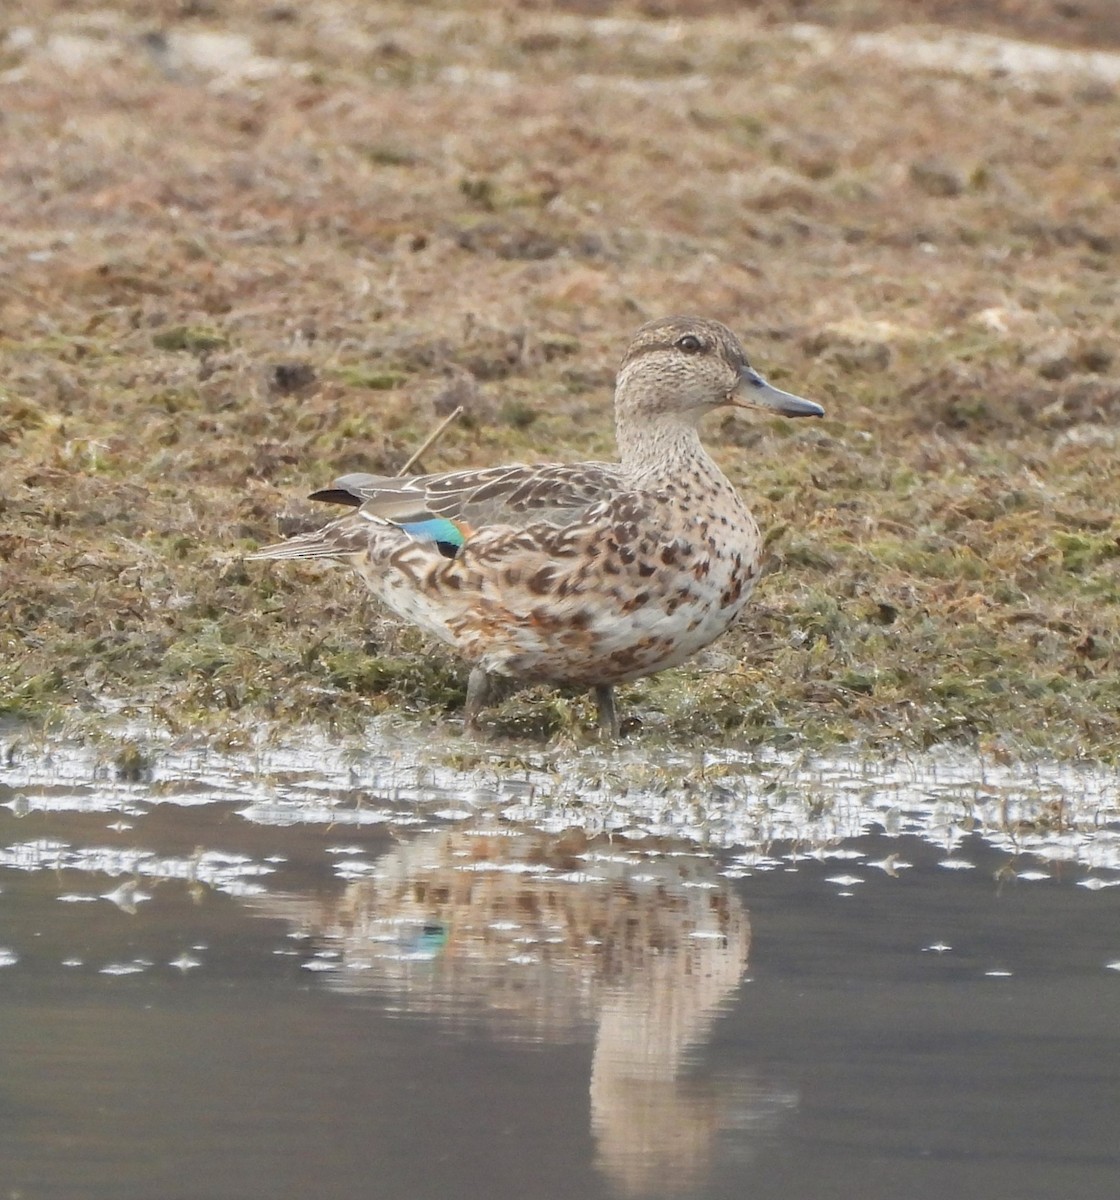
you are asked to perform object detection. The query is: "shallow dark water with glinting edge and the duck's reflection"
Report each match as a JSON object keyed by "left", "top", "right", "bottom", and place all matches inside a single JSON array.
[{"left": 0, "top": 733, "right": 1120, "bottom": 1200}]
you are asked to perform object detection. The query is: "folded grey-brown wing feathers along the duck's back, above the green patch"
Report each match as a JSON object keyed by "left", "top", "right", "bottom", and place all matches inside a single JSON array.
[{"left": 311, "top": 462, "right": 625, "bottom": 529}]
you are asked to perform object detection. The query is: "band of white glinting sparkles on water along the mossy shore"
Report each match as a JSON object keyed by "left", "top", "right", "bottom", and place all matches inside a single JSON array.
[{"left": 0, "top": 715, "right": 1120, "bottom": 868}]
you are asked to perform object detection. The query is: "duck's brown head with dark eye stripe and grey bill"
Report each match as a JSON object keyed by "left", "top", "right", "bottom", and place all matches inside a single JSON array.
[{"left": 615, "top": 317, "right": 825, "bottom": 424}]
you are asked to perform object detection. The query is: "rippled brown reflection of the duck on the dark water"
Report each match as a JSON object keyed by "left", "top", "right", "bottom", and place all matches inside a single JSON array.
[{"left": 254, "top": 824, "right": 793, "bottom": 1195}]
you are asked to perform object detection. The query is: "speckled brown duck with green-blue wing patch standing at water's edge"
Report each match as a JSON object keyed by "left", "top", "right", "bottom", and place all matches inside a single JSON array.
[{"left": 248, "top": 316, "right": 825, "bottom": 739}]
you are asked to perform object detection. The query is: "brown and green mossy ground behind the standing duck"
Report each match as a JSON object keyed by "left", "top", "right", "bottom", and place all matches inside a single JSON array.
[{"left": 0, "top": 0, "right": 1120, "bottom": 758}]
